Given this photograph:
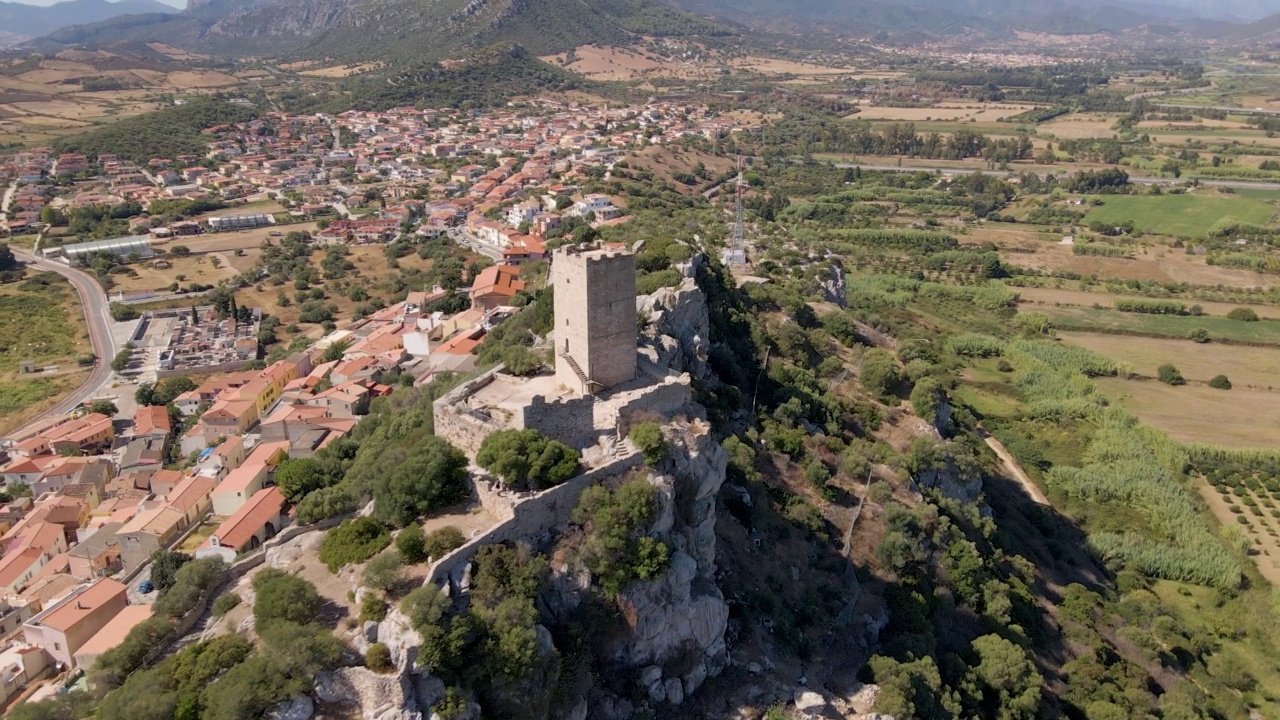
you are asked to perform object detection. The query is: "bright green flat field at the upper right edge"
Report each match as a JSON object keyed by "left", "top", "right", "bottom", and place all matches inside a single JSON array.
[{"left": 1084, "top": 195, "right": 1276, "bottom": 237}]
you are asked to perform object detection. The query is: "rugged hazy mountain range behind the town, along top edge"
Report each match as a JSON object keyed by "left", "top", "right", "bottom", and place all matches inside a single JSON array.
[{"left": 37, "top": 0, "right": 736, "bottom": 61}]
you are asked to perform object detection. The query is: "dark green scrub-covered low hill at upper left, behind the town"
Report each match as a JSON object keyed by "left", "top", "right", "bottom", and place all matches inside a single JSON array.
[{"left": 56, "top": 99, "right": 259, "bottom": 164}]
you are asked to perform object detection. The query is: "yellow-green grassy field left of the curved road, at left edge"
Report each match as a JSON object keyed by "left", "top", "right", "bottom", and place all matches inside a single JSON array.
[{"left": 0, "top": 273, "right": 91, "bottom": 433}]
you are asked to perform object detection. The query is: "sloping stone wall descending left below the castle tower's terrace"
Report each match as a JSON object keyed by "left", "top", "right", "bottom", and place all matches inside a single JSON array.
[{"left": 426, "top": 450, "right": 641, "bottom": 587}]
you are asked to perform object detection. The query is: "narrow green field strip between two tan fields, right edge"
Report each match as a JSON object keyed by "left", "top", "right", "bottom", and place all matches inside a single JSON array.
[{"left": 1037, "top": 305, "right": 1280, "bottom": 346}]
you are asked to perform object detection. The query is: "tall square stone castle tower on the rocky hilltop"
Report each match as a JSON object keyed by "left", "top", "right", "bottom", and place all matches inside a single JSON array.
[{"left": 552, "top": 245, "right": 636, "bottom": 395}]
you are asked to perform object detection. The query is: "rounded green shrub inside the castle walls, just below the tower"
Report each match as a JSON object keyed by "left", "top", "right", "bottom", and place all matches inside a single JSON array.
[{"left": 476, "top": 428, "right": 582, "bottom": 491}]
